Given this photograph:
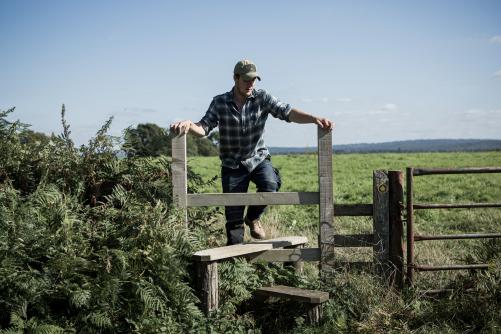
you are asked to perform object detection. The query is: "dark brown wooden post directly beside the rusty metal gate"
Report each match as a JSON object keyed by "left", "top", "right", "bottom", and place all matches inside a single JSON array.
[{"left": 388, "top": 171, "right": 404, "bottom": 289}]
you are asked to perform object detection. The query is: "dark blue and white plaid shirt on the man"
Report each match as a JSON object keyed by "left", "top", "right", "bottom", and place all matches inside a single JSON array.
[{"left": 198, "top": 89, "right": 292, "bottom": 171}]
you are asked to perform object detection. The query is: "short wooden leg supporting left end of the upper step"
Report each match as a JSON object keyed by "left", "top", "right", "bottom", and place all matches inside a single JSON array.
[{"left": 197, "top": 261, "right": 219, "bottom": 314}]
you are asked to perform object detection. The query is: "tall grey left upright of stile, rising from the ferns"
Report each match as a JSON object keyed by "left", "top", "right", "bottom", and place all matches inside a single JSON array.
[{"left": 171, "top": 134, "right": 188, "bottom": 224}]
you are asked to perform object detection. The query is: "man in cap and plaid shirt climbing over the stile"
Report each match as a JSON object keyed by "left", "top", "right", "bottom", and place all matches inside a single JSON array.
[{"left": 171, "top": 60, "right": 334, "bottom": 245}]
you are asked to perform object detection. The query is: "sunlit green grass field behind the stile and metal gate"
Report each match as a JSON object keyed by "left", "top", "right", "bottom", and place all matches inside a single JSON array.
[{"left": 188, "top": 152, "right": 501, "bottom": 288}]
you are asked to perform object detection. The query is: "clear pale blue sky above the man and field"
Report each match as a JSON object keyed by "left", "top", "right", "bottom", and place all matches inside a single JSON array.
[{"left": 0, "top": 0, "right": 501, "bottom": 147}]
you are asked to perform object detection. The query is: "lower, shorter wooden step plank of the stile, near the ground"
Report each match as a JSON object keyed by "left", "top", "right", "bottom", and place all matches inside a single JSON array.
[{"left": 255, "top": 285, "right": 329, "bottom": 304}]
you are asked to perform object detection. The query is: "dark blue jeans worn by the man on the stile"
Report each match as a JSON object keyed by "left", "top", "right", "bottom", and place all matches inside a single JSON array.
[{"left": 221, "top": 159, "right": 281, "bottom": 245}]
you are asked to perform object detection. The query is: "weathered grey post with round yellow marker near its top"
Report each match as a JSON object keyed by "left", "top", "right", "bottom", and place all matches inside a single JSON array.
[{"left": 373, "top": 170, "right": 390, "bottom": 279}]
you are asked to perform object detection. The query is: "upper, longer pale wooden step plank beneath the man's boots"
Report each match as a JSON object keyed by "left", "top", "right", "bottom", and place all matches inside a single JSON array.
[{"left": 193, "top": 236, "right": 308, "bottom": 262}]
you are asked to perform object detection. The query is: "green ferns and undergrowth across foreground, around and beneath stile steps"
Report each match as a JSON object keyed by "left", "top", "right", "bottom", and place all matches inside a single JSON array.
[{"left": 0, "top": 106, "right": 501, "bottom": 334}]
